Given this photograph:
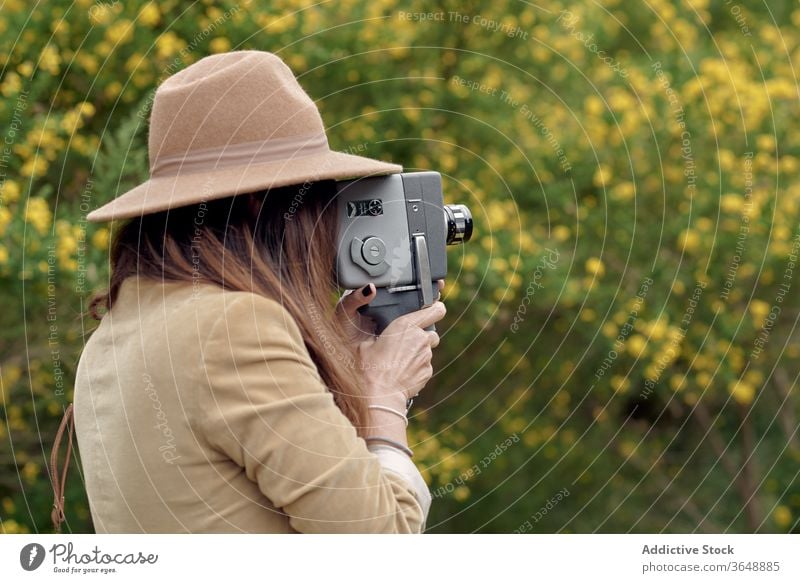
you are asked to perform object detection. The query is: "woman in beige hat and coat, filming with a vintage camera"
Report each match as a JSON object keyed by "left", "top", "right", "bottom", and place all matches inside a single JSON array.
[{"left": 75, "top": 51, "right": 445, "bottom": 532}]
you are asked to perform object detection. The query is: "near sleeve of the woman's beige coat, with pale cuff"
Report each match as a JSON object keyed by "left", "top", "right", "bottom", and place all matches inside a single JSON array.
[{"left": 199, "top": 292, "right": 430, "bottom": 533}]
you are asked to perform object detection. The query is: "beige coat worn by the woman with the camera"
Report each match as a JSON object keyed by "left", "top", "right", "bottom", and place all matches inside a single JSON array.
[{"left": 75, "top": 277, "right": 431, "bottom": 533}]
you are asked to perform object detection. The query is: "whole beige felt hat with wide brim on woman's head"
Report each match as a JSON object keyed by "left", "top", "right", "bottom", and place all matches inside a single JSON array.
[{"left": 87, "top": 51, "right": 403, "bottom": 222}]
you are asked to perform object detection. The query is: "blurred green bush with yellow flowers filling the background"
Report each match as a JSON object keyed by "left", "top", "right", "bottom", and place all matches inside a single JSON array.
[{"left": 0, "top": 0, "right": 800, "bottom": 533}]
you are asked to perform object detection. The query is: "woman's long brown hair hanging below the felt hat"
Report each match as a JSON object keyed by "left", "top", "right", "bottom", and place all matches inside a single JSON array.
[{"left": 89, "top": 181, "right": 367, "bottom": 434}]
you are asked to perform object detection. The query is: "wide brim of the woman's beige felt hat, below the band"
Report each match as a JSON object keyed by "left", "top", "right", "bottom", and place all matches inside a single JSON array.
[{"left": 86, "top": 151, "right": 403, "bottom": 223}]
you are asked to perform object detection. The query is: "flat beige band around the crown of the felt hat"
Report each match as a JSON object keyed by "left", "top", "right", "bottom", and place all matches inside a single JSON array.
[{"left": 150, "top": 132, "right": 330, "bottom": 178}]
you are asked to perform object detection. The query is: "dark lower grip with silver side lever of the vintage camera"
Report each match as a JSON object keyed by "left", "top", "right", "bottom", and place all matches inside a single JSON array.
[{"left": 358, "top": 234, "right": 439, "bottom": 334}]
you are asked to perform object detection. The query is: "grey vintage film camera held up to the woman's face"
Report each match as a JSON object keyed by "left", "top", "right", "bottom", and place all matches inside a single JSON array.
[{"left": 336, "top": 172, "right": 472, "bottom": 334}]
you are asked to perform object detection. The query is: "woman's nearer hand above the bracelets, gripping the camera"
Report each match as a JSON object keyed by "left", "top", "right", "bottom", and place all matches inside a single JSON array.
[{"left": 357, "top": 301, "right": 447, "bottom": 411}]
